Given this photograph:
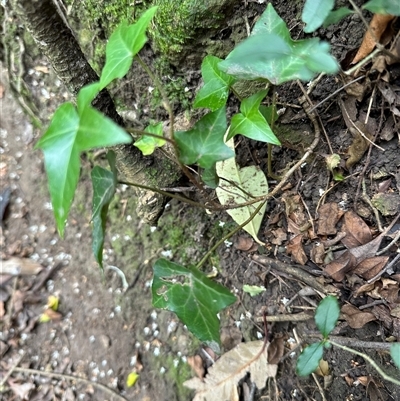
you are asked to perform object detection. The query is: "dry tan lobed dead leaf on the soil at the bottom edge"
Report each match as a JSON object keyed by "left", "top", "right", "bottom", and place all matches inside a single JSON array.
[{"left": 184, "top": 341, "right": 278, "bottom": 401}]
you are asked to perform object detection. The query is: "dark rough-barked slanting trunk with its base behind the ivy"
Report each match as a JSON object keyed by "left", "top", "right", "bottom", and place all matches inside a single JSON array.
[{"left": 13, "top": 0, "right": 179, "bottom": 224}]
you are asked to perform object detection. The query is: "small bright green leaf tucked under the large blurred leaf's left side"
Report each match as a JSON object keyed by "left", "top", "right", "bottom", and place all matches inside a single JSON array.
[{"left": 194, "top": 56, "right": 235, "bottom": 111}]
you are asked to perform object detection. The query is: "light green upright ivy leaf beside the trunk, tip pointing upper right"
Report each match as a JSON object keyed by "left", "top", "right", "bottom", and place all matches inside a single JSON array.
[{"left": 100, "top": 7, "right": 158, "bottom": 89}]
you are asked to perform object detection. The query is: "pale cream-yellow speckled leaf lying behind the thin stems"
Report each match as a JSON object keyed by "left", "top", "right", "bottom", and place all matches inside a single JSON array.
[{"left": 216, "top": 139, "right": 268, "bottom": 245}]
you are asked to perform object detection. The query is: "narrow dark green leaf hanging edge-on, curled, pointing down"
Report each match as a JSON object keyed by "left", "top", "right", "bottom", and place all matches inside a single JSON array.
[{"left": 91, "top": 166, "right": 117, "bottom": 268}]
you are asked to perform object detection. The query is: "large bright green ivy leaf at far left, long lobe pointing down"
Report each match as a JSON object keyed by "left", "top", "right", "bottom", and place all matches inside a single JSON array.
[{"left": 35, "top": 103, "right": 132, "bottom": 237}]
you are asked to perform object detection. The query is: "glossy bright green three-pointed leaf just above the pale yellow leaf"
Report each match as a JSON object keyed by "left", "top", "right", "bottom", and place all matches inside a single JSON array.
[{"left": 228, "top": 90, "right": 281, "bottom": 145}]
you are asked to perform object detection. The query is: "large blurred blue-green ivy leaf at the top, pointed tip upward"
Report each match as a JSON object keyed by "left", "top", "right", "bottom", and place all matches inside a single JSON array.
[{"left": 218, "top": 4, "right": 339, "bottom": 85}]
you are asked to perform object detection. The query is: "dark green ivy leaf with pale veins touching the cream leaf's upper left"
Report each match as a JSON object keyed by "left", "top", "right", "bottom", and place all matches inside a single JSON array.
[{"left": 175, "top": 107, "right": 234, "bottom": 169}]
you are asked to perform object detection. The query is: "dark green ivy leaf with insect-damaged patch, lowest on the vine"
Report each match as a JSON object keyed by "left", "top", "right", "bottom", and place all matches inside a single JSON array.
[{"left": 152, "top": 259, "right": 236, "bottom": 351}]
